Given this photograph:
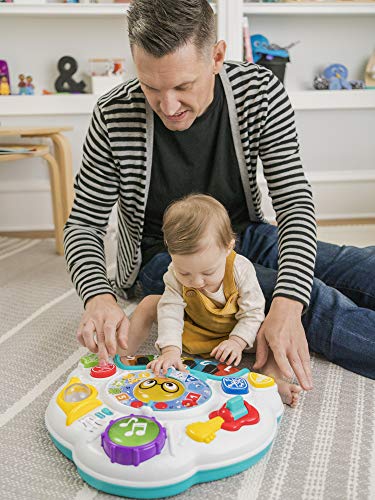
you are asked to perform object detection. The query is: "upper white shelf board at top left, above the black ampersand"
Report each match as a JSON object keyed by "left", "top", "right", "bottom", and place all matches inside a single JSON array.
[{"left": 0, "top": 3, "right": 129, "bottom": 17}]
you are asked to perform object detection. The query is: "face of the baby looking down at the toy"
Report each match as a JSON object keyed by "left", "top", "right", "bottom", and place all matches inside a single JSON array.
[{"left": 171, "top": 239, "right": 232, "bottom": 292}]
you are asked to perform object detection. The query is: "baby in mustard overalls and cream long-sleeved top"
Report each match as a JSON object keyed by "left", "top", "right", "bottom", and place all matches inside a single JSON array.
[{"left": 126, "top": 194, "right": 301, "bottom": 406}]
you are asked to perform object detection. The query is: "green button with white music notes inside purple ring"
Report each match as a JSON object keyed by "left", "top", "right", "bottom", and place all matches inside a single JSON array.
[{"left": 108, "top": 417, "right": 160, "bottom": 446}]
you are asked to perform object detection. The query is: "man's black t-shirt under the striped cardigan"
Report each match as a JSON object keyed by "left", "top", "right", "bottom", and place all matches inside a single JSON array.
[{"left": 141, "top": 76, "right": 250, "bottom": 265}]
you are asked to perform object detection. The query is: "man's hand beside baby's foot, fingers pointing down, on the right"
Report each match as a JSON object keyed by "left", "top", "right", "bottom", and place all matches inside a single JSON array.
[{"left": 254, "top": 297, "right": 313, "bottom": 390}]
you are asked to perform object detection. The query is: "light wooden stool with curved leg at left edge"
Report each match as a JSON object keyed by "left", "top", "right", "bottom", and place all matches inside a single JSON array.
[{"left": 0, "top": 144, "right": 67, "bottom": 255}]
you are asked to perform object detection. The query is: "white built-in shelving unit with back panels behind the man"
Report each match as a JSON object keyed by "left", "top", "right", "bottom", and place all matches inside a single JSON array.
[{"left": 0, "top": 0, "right": 375, "bottom": 231}]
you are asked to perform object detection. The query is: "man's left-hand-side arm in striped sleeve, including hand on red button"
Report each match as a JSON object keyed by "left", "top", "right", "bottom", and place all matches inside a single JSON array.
[{"left": 64, "top": 105, "right": 128, "bottom": 362}]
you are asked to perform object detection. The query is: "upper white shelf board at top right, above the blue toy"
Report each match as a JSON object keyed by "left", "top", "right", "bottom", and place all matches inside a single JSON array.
[{"left": 243, "top": 2, "right": 375, "bottom": 16}]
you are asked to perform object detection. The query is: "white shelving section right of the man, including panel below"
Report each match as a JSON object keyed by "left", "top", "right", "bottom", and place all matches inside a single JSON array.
[{"left": 240, "top": 0, "right": 375, "bottom": 222}]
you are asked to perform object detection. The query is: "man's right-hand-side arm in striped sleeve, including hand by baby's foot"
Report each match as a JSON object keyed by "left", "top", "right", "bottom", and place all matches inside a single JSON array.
[{"left": 255, "top": 76, "right": 316, "bottom": 389}]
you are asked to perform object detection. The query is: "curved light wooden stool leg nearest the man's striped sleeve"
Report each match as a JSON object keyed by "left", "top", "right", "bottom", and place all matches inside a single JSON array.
[{"left": 43, "top": 153, "right": 65, "bottom": 255}]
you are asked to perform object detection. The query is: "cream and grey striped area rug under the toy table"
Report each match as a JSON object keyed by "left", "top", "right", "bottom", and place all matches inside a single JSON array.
[{"left": 0, "top": 238, "right": 375, "bottom": 500}]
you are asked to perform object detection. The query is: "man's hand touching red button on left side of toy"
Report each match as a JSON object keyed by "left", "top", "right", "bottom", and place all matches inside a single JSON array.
[{"left": 77, "top": 294, "right": 129, "bottom": 365}]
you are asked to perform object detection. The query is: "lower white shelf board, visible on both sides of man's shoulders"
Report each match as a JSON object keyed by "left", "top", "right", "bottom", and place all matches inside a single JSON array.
[{"left": 0, "top": 89, "right": 375, "bottom": 117}]
